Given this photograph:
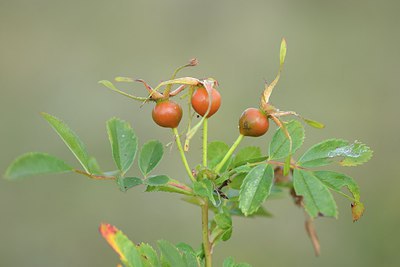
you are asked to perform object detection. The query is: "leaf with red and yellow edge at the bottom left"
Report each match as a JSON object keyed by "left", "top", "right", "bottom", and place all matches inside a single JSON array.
[{"left": 100, "top": 224, "right": 143, "bottom": 267}]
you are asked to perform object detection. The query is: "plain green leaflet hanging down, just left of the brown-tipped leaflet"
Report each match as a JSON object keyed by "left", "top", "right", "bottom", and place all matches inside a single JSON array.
[{"left": 293, "top": 169, "right": 337, "bottom": 218}]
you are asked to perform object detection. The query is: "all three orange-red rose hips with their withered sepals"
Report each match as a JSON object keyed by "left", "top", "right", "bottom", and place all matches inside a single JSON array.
[{"left": 100, "top": 39, "right": 316, "bottom": 155}]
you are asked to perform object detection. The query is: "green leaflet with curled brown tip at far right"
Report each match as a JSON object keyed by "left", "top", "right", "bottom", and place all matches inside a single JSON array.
[{"left": 314, "top": 171, "right": 360, "bottom": 201}]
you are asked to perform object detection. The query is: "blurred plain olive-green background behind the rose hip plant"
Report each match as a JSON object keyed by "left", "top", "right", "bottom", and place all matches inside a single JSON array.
[{"left": 0, "top": 0, "right": 400, "bottom": 266}]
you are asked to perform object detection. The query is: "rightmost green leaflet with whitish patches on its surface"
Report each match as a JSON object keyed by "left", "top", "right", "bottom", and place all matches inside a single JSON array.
[{"left": 298, "top": 139, "right": 372, "bottom": 168}]
